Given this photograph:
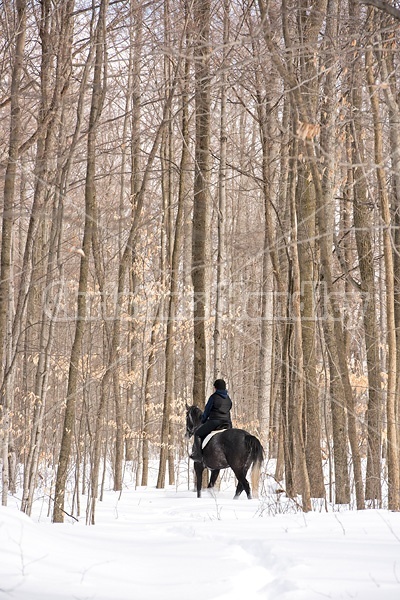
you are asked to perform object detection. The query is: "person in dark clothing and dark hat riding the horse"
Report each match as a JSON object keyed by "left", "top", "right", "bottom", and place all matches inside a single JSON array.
[{"left": 190, "top": 379, "right": 232, "bottom": 461}]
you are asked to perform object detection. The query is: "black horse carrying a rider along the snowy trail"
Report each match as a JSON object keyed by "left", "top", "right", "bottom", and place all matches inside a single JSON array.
[{"left": 186, "top": 405, "right": 264, "bottom": 500}]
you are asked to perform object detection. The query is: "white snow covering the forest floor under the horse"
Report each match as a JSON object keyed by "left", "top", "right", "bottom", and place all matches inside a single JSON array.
[{"left": 0, "top": 469, "right": 400, "bottom": 600}]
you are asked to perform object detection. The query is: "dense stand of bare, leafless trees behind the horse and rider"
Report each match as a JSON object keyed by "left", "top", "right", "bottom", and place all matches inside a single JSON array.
[{"left": 0, "top": 0, "right": 400, "bottom": 523}]
